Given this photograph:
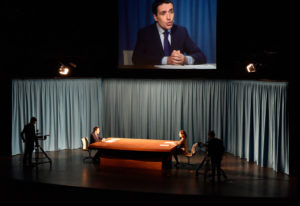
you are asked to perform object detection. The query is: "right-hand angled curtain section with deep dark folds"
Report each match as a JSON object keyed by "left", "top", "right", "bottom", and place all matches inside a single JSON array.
[{"left": 229, "top": 81, "right": 289, "bottom": 174}]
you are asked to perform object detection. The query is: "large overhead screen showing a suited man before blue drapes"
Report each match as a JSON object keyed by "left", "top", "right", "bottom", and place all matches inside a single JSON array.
[{"left": 118, "top": 0, "right": 217, "bottom": 70}]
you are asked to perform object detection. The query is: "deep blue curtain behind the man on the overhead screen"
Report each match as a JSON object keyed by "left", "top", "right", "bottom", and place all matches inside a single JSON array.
[{"left": 118, "top": 0, "right": 217, "bottom": 64}]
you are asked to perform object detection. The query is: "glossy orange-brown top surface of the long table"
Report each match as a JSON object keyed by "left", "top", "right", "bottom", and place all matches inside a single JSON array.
[{"left": 89, "top": 137, "right": 177, "bottom": 152}]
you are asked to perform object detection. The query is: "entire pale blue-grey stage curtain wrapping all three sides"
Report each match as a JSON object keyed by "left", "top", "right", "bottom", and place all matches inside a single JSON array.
[{"left": 12, "top": 78, "right": 289, "bottom": 174}]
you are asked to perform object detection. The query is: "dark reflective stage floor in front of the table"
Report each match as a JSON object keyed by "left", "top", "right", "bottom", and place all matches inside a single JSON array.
[{"left": 1, "top": 149, "right": 298, "bottom": 205}]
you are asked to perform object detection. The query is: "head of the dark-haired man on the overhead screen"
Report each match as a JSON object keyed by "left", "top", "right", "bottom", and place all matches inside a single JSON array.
[{"left": 153, "top": 3, "right": 174, "bottom": 29}]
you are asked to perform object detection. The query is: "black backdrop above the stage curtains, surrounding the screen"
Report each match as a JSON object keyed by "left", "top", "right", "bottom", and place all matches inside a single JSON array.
[{"left": 0, "top": 0, "right": 292, "bottom": 79}]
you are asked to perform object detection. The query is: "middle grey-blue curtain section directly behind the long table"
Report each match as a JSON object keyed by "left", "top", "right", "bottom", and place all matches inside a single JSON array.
[{"left": 103, "top": 79, "right": 228, "bottom": 146}]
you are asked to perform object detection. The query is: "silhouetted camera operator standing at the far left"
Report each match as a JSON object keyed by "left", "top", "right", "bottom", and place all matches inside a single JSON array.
[{"left": 21, "top": 117, "right": 37, "bottom": 166}]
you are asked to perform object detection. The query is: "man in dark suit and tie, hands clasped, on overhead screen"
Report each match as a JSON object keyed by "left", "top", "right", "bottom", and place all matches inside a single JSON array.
[{"left": 132, "top": 0, "right": 206, "bottom": 65}]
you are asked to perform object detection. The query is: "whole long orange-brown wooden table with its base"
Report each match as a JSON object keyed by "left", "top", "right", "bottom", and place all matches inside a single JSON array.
[{"left": 89, "top": 137, "right": 177, "bottom": 169}]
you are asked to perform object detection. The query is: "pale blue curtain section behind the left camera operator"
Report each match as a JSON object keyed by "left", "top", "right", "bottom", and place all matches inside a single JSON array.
[{"left": 12, "top": 79, "right": 103, "bottom": 154}]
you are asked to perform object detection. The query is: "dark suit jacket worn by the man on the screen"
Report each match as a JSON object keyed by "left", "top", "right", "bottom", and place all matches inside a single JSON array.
[{"left": 132, "top": 23, "right": 206, "bottom": 65}]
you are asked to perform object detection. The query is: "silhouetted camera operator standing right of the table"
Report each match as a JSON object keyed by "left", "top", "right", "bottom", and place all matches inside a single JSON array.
[{"left": 207, "top": 131, "right": 225, "bottom": 182}]
